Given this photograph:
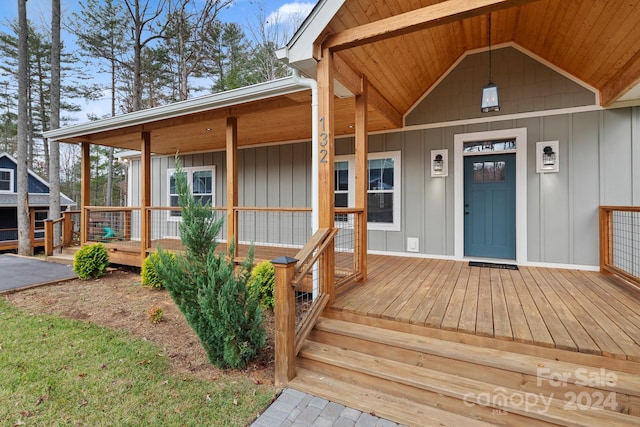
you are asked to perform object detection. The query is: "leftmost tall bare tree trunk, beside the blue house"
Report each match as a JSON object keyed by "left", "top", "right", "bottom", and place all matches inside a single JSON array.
[{"left": 17, "top": 0, "right": 31, "bottom": 255}]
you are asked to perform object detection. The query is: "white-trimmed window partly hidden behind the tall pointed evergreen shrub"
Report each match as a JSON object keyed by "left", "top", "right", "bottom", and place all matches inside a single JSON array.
[{"left": 167, "top": 166, "right": 216, "bottom": 221}]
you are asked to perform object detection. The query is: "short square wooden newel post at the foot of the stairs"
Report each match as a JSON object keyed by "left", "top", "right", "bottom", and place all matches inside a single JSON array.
[{"left": 271, "top": 257, "right": 298, "bottom": 387}]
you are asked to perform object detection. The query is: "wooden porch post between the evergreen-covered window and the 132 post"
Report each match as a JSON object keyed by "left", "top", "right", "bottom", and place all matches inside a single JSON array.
[{"left": 227, "top": 117, "right": 238, "bottom": 258}]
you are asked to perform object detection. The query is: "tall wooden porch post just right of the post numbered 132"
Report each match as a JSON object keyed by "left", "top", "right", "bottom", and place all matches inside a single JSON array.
[{"left": 354, "top": 76, "right": 369, "bottom": 281}]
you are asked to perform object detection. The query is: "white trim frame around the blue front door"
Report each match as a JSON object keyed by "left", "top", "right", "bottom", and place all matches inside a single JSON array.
[{"left": 453, "top": 128, "right": 527, "bottom": 264}]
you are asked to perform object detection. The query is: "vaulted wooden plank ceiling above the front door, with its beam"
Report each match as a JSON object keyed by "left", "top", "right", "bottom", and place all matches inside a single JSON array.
[{"left": 324, "top": 0, "right": 640, "bottom": 114}]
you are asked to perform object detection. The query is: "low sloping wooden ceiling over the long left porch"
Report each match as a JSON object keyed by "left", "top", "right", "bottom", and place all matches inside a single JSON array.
[{"left": 56, "top": 90, "right": 393, "bottom": 154}]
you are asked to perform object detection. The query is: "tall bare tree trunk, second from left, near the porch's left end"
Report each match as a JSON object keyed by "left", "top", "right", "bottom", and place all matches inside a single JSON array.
[{"left": 45, "top": 0, "right": 61, "bottom": 245}]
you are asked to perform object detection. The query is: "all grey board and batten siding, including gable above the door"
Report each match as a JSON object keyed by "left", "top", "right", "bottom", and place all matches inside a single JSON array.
[{"left": 129, "top": 47, "right": 640, "bottom": 267}]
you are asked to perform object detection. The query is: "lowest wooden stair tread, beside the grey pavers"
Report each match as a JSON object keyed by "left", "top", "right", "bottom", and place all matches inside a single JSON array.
[{"left": 289, "top": 368, "right": 493, "bottom": 427}]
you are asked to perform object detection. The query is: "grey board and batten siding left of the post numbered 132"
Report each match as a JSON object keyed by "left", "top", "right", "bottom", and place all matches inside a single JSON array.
[{"left": 129, "top": 142, "right": 311, "bottom": 246}]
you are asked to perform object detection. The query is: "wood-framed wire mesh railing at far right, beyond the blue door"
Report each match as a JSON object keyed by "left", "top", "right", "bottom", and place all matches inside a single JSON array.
[{"left": 600, "top": 206, "right": 640, "bottom": 287}]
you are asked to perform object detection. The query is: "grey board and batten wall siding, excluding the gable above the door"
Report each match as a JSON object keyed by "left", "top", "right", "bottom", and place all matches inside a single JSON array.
[{"left": 130, "top": 107, "right": 640, "bottom": 266}]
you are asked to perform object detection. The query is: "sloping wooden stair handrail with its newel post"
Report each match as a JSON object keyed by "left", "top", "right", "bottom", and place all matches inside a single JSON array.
[{"left": 272, "top": 228, "right": 338, "bottom": 387}]
